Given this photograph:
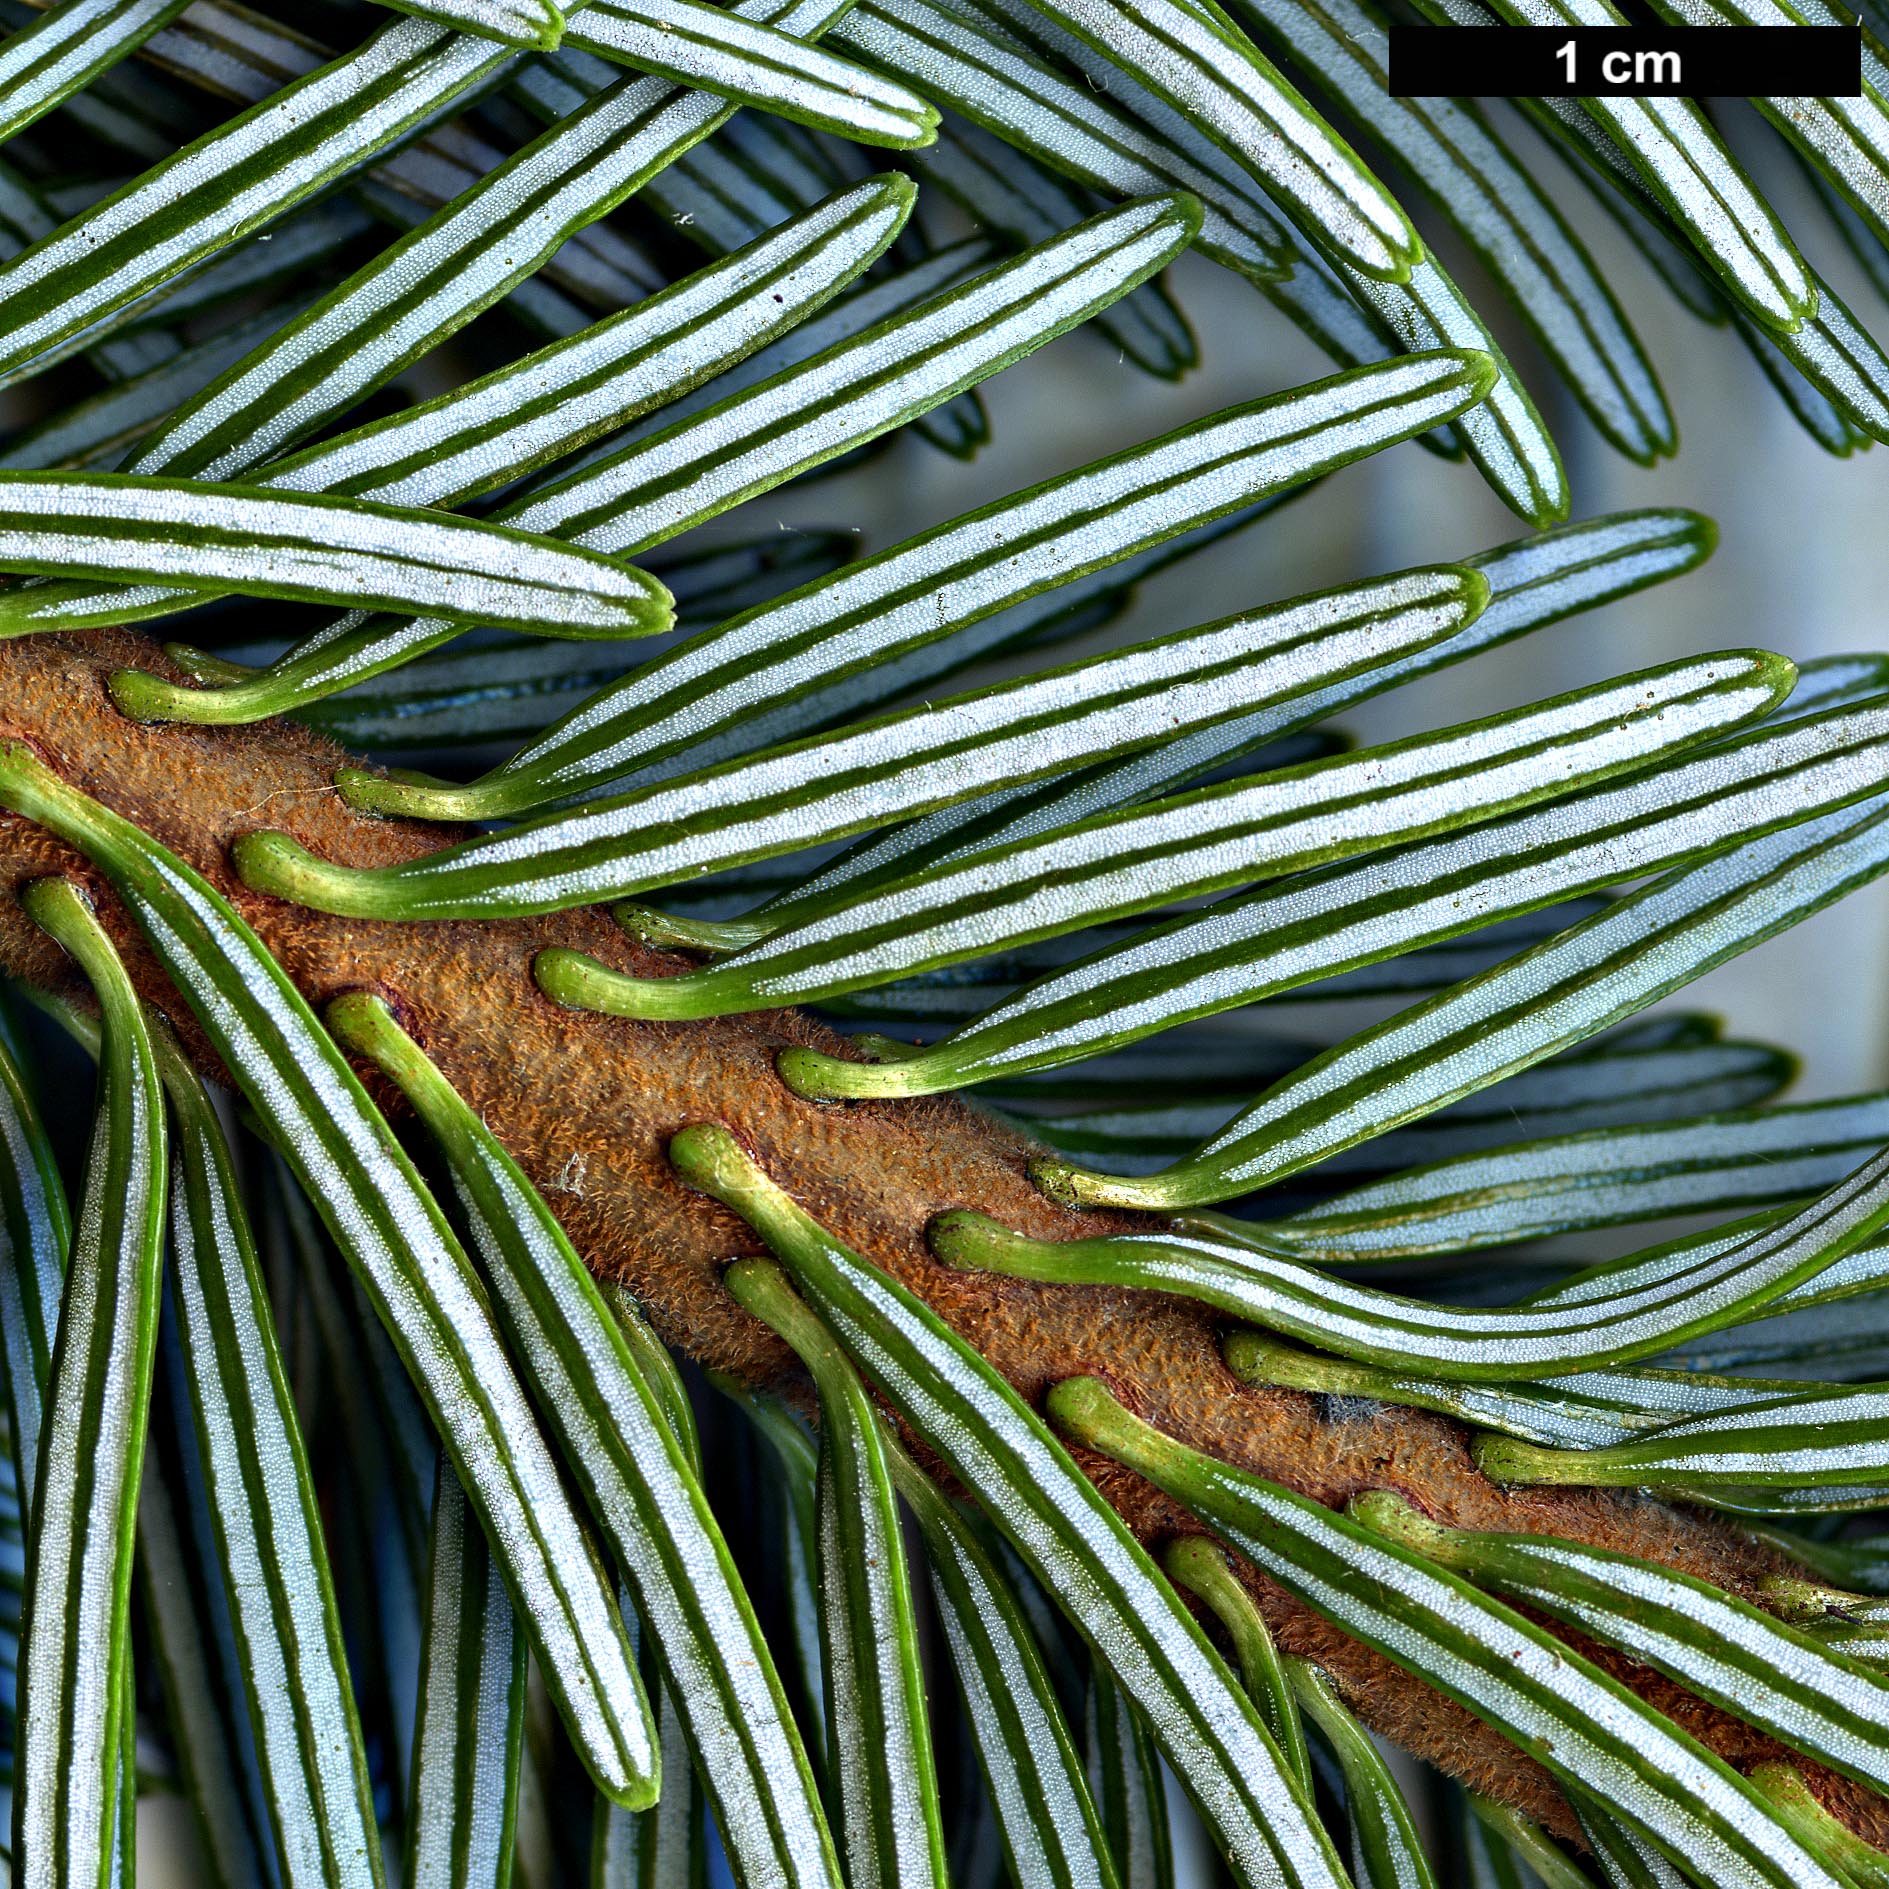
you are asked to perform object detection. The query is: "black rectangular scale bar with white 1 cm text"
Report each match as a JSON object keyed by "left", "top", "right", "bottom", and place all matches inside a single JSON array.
[{"left": 1390, "top": 26, "right": 1863, "bottom": 98}]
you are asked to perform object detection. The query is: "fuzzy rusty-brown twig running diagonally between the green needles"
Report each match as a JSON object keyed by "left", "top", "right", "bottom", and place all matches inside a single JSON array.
[{"left": 0, "top": 631, "right": 1889, "bottom": 1847}]
